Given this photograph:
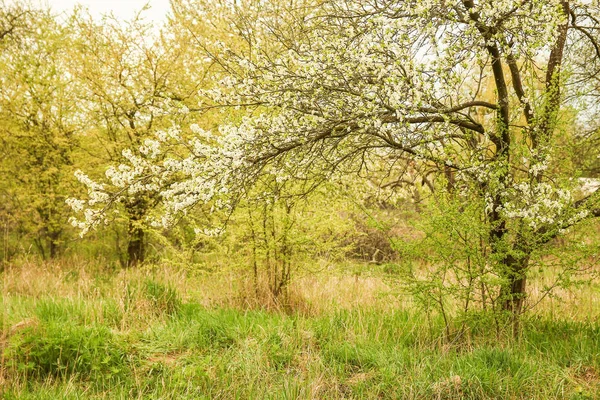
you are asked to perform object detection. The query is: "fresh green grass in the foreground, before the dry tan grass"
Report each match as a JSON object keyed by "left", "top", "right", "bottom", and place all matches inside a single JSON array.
[{"left": 3, "top": 300, "right": 600, "bottom": 399}]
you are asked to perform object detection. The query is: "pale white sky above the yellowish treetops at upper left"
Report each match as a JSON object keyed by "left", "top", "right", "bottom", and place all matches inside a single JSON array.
[{"left": 21, "top": 0, "right": 170, "bottom": 22}]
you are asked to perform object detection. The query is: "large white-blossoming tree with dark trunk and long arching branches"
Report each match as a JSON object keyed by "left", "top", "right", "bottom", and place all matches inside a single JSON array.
[{"left": 72, "top": 0, "right": 600, "bottom": 324}]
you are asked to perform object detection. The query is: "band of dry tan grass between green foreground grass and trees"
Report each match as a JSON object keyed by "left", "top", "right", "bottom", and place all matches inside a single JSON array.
[{"left": 2, "top": 260, "right": 600, "bottom": 323}]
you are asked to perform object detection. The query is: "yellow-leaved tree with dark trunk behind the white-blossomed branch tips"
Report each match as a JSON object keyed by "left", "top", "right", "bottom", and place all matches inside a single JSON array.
[{"left": 68, "top": 11, "right": 202, "bottom": 266}]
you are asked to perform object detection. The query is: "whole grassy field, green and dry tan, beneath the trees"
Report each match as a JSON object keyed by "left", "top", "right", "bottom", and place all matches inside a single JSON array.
[{"left": 0, "top": 263, "right": 600, "bottom": 399}]
